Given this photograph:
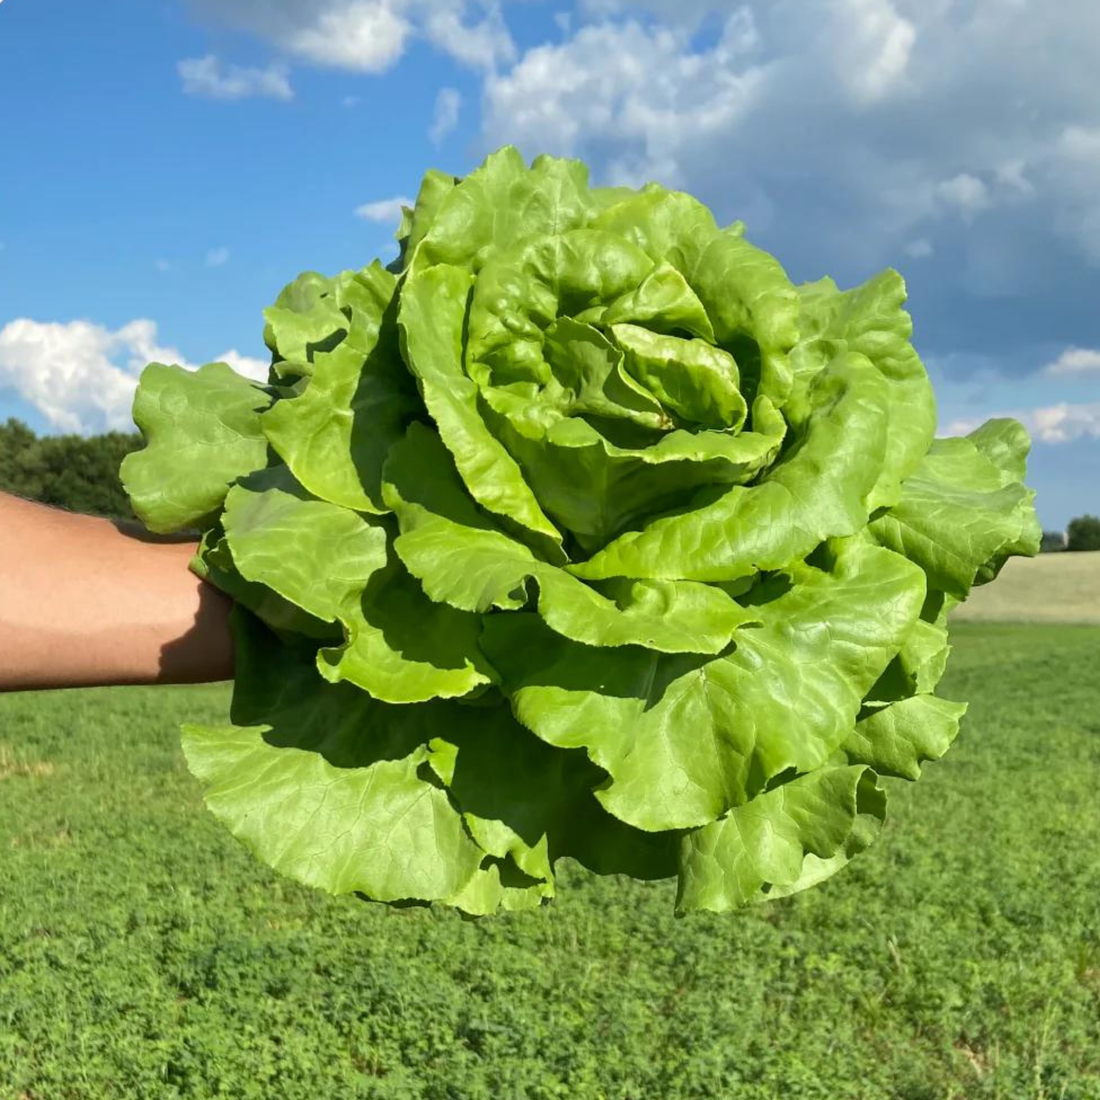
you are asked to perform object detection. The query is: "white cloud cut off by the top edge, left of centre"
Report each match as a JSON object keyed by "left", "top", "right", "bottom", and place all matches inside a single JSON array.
[{"left": 191, "top": 0, "right": 516, "bottom": 73}]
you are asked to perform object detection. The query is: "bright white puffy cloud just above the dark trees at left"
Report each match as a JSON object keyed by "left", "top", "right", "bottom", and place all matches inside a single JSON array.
[{"left": 0, "top": 318, "right": 267, "bottom": 432}]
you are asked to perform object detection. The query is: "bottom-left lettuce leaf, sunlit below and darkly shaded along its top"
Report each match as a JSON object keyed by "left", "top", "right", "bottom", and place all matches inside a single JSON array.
[{"left": 184, "top": 612, "right": 495, "bottom": 901}]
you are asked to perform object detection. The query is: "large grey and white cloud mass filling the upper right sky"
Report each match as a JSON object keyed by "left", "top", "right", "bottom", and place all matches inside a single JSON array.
[{"left": 483, "top": 0, "right": 1100, "bottom": 332}]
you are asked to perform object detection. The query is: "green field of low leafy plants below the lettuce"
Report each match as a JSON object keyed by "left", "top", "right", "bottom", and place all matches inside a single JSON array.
[{"left": 0, "top": 624, "right": 1100, "bottom": 1100}]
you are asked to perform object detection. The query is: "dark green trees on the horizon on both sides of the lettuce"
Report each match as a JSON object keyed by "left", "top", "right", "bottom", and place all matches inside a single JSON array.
[{"left": 0, "top": 418, "right": 1100, "bottom": 551}]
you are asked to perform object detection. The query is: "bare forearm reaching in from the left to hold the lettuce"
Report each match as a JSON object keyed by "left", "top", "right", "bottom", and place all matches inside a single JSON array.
[{"left": 0, "top": 493, "right": 233, "bottom": 691}]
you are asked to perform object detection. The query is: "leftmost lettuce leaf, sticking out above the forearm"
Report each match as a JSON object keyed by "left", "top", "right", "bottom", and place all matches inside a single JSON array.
[{"left": 121, "top": 363, "right": 271, "bottom": 534}]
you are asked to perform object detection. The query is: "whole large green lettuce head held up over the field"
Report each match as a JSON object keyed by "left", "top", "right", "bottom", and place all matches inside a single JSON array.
[{"left": 122, "top": 147, "right": 1040, "bottom": 915}]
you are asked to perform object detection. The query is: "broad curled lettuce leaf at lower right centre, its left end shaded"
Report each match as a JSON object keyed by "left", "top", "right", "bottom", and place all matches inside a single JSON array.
[{"left": 483, "top": 542, "right": 924, "bottom": 831}]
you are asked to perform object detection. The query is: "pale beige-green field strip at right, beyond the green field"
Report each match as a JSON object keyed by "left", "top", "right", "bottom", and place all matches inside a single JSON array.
[{"left": 954, "top": 551, "right": 1100, "bottom": 623}]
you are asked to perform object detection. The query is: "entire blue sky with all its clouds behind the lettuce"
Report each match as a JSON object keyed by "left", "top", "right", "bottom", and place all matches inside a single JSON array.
[{"left": 0, "top": 0, "right": 1100, "bottom": 527}]
